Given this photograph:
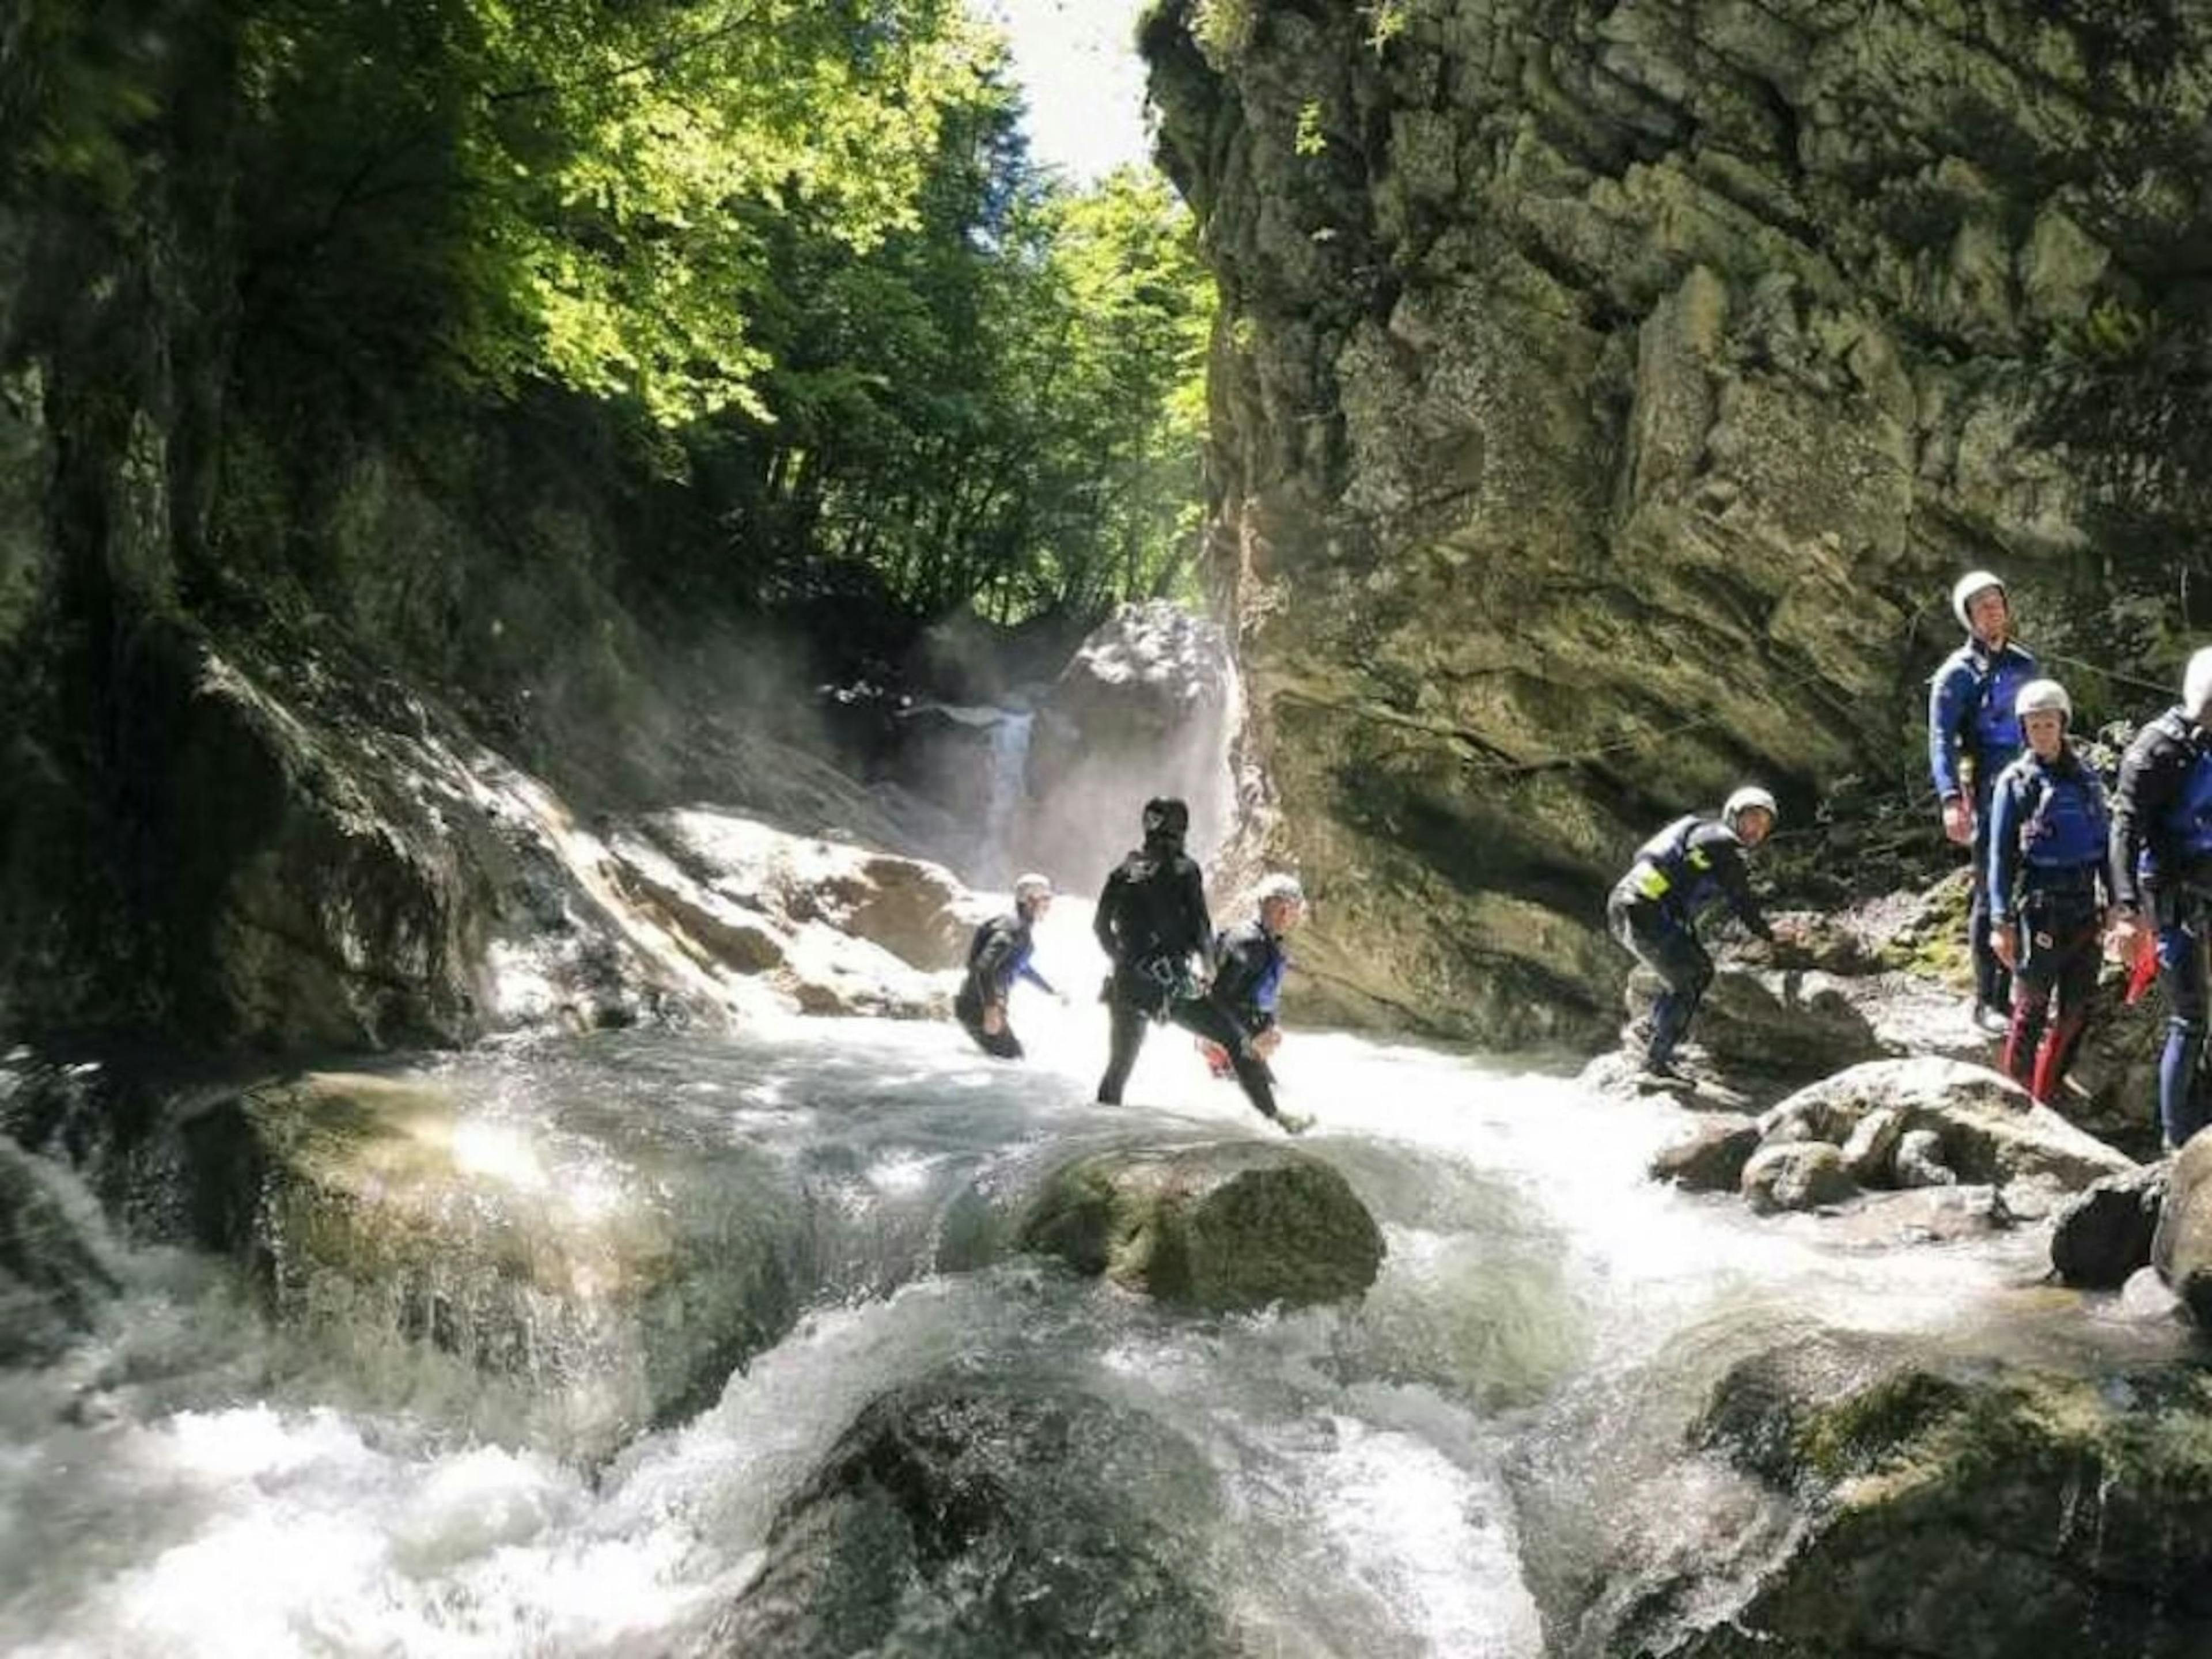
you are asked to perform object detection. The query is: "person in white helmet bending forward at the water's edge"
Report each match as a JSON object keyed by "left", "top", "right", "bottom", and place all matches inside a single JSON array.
[{"left": 1606, "top": 785, "right": 1777, "bottom": 1082}]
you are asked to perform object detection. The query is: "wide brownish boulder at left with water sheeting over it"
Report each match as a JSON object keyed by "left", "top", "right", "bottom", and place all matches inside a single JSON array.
[{"left": 177, "top": 1073, "right": 812, "bottom": 1458}]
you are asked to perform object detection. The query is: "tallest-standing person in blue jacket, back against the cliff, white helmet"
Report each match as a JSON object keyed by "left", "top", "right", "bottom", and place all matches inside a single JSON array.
[{"left": 1929, "top": 571, "right": 2037, "bottom": 1035}]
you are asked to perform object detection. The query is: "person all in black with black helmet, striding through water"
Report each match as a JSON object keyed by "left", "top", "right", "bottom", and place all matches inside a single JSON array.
[{"left": 1093, "top": 798, "right": 1305, "bottom": 1132}]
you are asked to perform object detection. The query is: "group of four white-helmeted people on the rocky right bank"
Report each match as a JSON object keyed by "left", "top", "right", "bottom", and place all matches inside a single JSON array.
[{"left": 1608, "top": 571, "right": 2212, "bottom": 1148}]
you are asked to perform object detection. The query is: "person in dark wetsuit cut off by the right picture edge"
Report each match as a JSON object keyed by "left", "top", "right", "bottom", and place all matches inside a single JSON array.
[{"left": 2106, "top": 646, "right": 2212, "bottom": 1148}]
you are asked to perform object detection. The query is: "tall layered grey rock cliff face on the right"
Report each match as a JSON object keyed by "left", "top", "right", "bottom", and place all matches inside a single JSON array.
[{"left": 1143, "top": 0, "right": 2212, "bottom": 1042}]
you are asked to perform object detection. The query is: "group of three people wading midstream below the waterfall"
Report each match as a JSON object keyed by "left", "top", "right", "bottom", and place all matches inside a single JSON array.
[{"left": 953, "top": 796, "right": 1309, "bottom": 1135}]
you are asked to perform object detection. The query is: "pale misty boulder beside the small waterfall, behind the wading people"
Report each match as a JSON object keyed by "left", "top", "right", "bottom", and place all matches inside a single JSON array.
[{"left": 1016, "top": 600, "right": 1237, "bottom": 893}]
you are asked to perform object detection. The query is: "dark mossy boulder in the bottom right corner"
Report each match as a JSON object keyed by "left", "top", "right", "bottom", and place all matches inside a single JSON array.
[{"left": 1637, "top": 1336, "right": 2212, "bottom": 1659}]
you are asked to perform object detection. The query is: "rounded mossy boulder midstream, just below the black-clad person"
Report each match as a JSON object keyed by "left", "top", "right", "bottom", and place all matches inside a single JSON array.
[{"left": 1022, "top": 1141, "right": 1382, "bottom": 1312}]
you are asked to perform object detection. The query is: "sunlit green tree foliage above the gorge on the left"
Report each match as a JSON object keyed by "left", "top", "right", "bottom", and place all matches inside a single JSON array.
[{"left": 13, "top": 0, "right": 1212, "bottom": 641}]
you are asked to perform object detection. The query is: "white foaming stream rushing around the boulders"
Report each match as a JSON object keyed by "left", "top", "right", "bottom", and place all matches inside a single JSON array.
[{"left": 0, "top": 907, "right": 2176, "bottom": 1659}]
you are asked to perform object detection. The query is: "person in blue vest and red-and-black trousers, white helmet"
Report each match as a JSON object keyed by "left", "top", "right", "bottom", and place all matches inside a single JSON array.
[{"left": 1986, "top": 679, "right": 2110, "bottom": 1104}]
